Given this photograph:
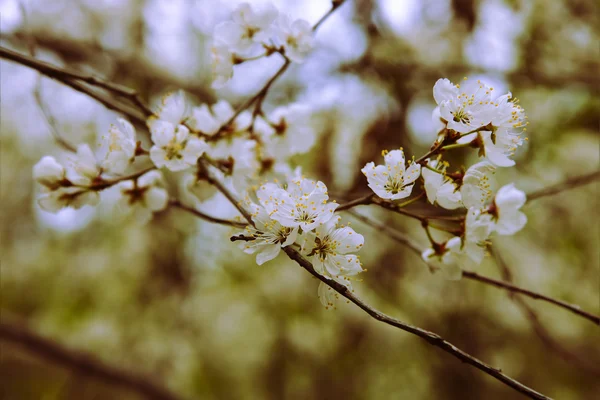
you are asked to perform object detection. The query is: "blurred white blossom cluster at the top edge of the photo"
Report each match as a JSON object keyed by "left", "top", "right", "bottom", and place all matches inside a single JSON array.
[{"left": 212, "top": 3, "right": 313, "bottom": 87}]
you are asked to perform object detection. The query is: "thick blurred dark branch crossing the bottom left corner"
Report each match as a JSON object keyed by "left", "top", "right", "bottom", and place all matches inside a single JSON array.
[{"left": 0, "top": 321, "right": 181, "bottom": 400}]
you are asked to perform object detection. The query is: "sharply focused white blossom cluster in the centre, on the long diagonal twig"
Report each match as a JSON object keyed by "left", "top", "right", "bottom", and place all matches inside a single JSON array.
[{"left": 238, "top": 177, "right": 364, "bottom": 307}]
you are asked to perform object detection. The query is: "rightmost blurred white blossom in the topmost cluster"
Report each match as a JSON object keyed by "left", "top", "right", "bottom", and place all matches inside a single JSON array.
[{"left": 276, "top": 14, "right": 314, "bottom": 63}]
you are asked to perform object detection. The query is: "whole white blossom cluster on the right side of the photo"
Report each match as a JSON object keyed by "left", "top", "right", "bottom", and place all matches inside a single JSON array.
[{"left": 362, "top": 79, "right": 527, "bottom": 279}]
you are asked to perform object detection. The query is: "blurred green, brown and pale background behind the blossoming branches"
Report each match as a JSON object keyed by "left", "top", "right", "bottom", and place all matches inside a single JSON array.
[{"left": 0, "top": 0, "right": 600, "bottom": 400}]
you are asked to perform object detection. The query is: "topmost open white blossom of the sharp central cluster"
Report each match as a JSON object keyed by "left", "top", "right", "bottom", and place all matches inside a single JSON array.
[{"left": 257, "top": 178, "right": 338, "bottom": 232}]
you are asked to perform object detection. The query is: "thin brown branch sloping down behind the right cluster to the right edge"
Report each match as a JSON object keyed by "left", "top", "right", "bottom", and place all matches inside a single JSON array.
[{"left": 351, "top": 211, "right": 600, "bottom": 325}]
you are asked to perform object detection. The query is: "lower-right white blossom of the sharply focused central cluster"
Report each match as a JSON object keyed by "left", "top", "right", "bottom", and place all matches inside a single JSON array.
[{"left": 303, "top": 215, "right": 365, "bottom": 286}]
